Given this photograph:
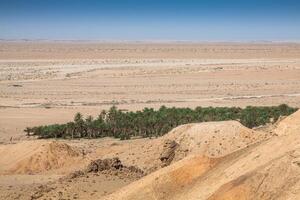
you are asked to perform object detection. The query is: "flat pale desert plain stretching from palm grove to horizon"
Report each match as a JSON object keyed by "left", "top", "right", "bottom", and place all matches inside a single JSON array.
[{"left": 0, "top": 41, "right": 300, "bottom": 142}]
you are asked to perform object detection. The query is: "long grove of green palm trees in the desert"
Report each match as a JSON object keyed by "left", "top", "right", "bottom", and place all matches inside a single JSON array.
[{"left": 24, "top": 104, "right": 297, "bottom": 140}]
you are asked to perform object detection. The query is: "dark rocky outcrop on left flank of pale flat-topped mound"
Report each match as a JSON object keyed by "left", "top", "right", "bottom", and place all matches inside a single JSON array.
[{"left": 159, "top": 140, "right": 179, "bottom": 167}]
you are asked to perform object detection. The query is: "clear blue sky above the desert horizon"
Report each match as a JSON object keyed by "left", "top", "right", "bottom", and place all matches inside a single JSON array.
[{"left": 0, "top": 0, "right": 300, "bottom": 41}]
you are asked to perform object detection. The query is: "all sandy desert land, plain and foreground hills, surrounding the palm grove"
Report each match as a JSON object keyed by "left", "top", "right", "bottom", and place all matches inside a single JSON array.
[{"left": 0, "top": 41, "right": 300, "bottom": 200}]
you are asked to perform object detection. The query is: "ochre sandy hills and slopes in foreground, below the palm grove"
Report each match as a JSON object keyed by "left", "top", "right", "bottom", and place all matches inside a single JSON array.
[{"left": 0, "top": 111, "right": 300, "bottom": 200}]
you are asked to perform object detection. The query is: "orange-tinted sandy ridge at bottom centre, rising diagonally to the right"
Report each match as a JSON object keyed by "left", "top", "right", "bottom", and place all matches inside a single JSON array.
[{"left": 104, "top": 156, "right": 218, "bottom": 200}]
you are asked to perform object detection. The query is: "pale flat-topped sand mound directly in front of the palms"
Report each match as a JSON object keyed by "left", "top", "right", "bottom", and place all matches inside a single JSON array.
[{"left": 162, "top": 121, "right": 270, "bottom": 157}]
